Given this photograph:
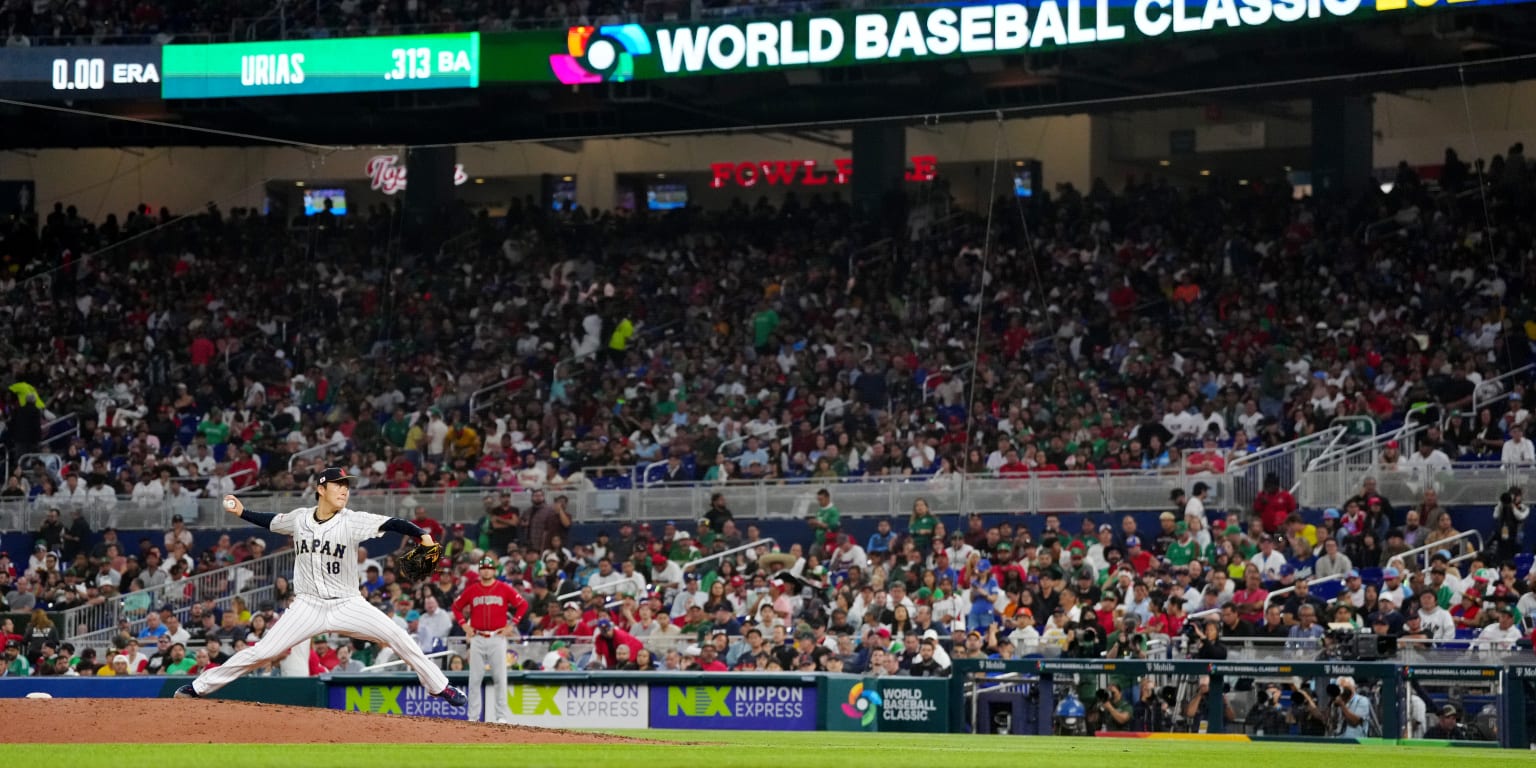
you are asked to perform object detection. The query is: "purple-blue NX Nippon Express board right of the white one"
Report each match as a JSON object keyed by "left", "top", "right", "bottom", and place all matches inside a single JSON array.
[{"left": 651, "top": 680, "right": 817, "bottom": 731}]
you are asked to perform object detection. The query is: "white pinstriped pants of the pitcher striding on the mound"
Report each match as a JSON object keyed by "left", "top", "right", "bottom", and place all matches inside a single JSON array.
[{"left": 192, "top": 594, "right": 448, "bottom": 696}]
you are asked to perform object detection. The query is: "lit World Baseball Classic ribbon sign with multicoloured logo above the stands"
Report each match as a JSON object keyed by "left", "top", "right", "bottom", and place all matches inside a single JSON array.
[{"left": 481, "top": 0, "right": 1531, "bottom": 84}]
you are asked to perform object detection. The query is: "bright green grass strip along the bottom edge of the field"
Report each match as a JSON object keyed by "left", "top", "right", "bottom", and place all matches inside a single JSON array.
[{"left": 12, "top": 731, "right": 1536, "bottom": 768}]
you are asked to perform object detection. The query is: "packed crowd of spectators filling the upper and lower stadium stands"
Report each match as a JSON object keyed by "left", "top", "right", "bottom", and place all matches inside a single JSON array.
[{"left": 0, "top": 146, "right": 1536, "bottom": 737}]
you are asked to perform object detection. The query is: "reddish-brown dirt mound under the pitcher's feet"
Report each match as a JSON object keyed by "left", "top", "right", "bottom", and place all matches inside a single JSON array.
[{"left": 0, "top": 699, "right": 642, "bottom": 743}]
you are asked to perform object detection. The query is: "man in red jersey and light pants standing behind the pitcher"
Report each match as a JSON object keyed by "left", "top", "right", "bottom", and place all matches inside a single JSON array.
[{"left": 453, "top": 558, "right": 528, "bottom": 722}]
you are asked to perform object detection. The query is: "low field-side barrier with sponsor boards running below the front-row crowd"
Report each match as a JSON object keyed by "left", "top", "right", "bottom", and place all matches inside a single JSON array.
[{"left": 0, "top": 659, "right": 1536, "bottom": 750}]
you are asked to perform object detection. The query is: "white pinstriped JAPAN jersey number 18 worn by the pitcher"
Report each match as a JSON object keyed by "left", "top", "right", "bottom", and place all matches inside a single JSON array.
[{"left": 272, "top": 507, "right": 389, "bottom": 601}]
